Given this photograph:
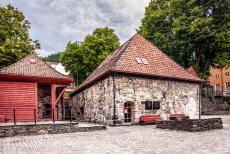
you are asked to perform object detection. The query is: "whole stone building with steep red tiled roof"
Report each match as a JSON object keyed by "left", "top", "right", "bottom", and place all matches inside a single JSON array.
[{"left": 71, "top": 33, "right": 203, "bottom": 123}]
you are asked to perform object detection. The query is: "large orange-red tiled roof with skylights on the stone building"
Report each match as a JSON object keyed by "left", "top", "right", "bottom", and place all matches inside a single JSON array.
[{"left": 71, "top": 33, "right": 203, "bottom": 93}]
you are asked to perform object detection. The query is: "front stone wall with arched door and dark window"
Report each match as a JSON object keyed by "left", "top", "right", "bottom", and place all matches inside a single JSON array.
[{"left": 115, "top": 75, "right": 199, "bottom": 122}]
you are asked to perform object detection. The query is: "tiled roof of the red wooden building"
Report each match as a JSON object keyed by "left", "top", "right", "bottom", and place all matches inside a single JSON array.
[{"left": 0, "top": 53, "right": 73, "bottom": 82}]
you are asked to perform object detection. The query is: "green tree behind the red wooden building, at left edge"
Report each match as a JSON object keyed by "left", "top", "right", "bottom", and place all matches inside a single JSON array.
[{"left": 0, "top": 5, "right": 40, "bottom": 68}]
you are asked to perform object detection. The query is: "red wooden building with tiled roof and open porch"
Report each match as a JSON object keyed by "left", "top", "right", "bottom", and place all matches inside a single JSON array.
[{"left": 0, "top": 53, "right": 73, "bottom": 122}]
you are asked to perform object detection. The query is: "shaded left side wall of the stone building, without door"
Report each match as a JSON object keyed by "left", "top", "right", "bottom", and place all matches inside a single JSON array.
[{"left": 72, "top": 77, "right": 113, "bottom": 123}]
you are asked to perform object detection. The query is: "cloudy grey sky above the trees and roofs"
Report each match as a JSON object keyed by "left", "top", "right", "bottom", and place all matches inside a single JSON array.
[{"left": 0, "top": 0, "right": 150, "bottom": 56}]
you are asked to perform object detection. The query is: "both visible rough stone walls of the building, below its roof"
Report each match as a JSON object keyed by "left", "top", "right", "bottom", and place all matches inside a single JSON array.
[{"left": 72, "top": 74, "right": 199, "bottom": 123}]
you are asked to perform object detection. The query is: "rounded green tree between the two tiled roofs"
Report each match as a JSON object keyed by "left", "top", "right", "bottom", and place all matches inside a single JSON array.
[{"left": 60, "top": 27, "right": 120, "bottom": 85}]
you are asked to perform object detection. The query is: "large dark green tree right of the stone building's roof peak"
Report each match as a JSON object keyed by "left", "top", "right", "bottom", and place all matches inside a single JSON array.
[{"left": 139, "top": 0, "right": 230, "bottom": 78}]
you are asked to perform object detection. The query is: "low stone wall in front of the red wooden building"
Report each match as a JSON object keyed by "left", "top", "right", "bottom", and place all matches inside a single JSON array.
[{"left": 0, "top": 123, "right": 106, "bottom": 138}]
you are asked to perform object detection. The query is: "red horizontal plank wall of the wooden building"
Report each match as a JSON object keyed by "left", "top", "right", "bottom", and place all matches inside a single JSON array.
[{"left": 0, "top": 81, "right": 37, "bottom": 122}]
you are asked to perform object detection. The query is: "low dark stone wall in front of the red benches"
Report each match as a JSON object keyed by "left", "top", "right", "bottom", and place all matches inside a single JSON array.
[{"left": 156, "top": 118, "right": 223, "bottom": 132}]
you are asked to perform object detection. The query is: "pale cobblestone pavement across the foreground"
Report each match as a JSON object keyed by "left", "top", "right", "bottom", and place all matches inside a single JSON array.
[{"left": 0, "top": 116, "right": 230, "bottom": 154}]
